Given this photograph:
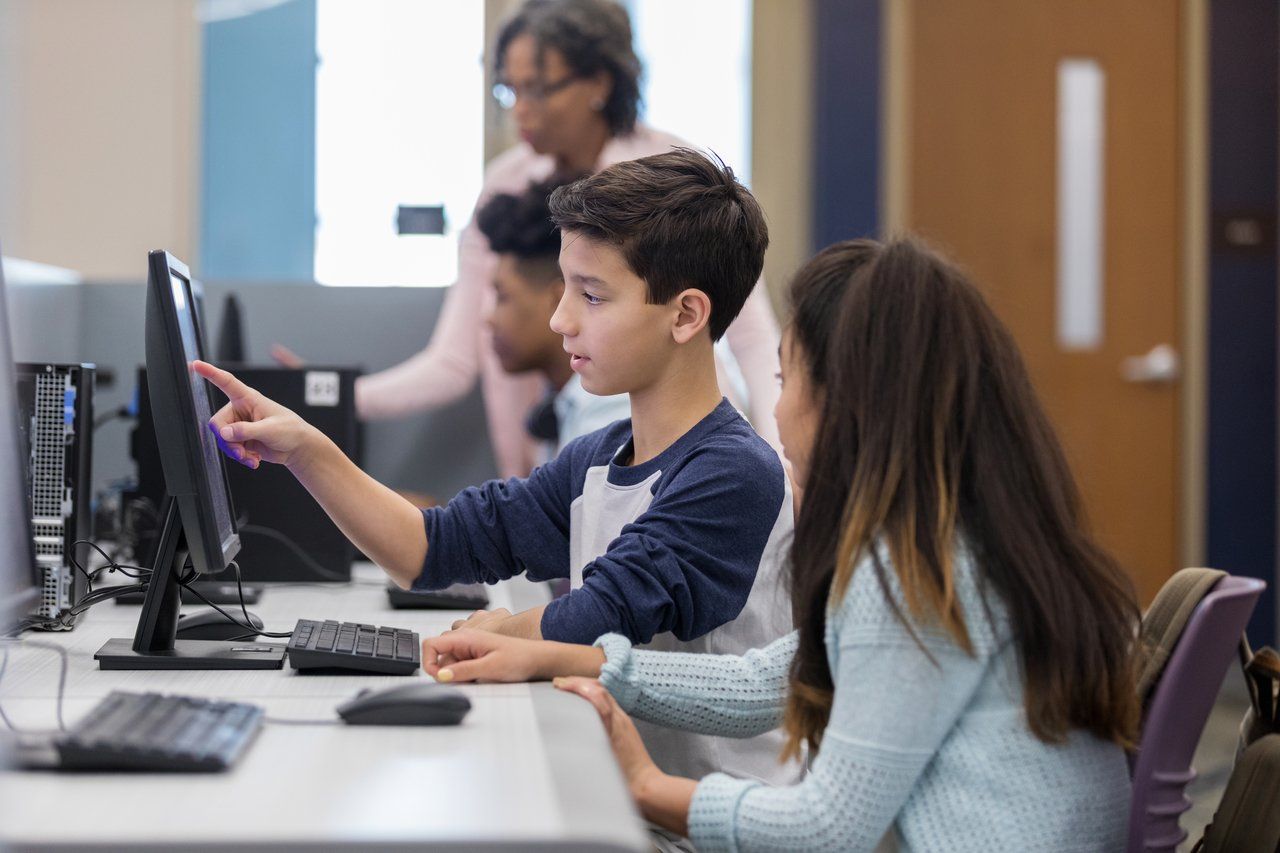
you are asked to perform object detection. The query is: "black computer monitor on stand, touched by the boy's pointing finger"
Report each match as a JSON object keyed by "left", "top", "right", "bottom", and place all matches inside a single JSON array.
[{"left": 95, "top": 251, "right": 284, "bottom": 670}]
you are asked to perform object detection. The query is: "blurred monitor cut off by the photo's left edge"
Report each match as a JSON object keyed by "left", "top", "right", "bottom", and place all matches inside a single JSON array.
[{"left": 0, "top": 236, "right": 42, "bottom": 635}]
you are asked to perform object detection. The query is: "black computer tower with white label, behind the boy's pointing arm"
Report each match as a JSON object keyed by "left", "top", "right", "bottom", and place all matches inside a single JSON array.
[{"left": 125, "top": 365, "right": 361, "bottom": 583}]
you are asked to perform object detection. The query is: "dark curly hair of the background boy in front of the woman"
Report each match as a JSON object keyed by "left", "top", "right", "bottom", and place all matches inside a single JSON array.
[{"left": 476, "top": 177, "right": 568, "bottom": 284}]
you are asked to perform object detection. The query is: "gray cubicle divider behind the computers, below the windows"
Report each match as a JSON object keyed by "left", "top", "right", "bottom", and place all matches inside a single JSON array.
[{"left": 10, "top": 279, "right": 495, "bottom": 501}]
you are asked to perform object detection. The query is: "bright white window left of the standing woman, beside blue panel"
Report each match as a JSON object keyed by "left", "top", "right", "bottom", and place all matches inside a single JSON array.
[{"left": 315, "top": 0, "right": 486, "bottom": 287}]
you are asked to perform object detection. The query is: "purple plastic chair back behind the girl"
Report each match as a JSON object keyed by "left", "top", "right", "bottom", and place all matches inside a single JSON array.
[{"left": 1126, "top": 575, "right": 1266, "bottom": 853}]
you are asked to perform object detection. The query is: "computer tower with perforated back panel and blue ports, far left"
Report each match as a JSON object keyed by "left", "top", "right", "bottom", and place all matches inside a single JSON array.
[{"left": 14, "top": 362, "right": 93, "bottom": 630}]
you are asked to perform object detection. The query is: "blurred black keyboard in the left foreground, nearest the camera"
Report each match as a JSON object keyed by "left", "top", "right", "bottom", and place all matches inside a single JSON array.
[{"left": 54, "top": 690, "right": 262, "bottom": 772}]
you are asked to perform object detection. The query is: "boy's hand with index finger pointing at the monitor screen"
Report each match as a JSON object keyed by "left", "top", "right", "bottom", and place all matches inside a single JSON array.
[{"left": 192, "top": 361, "right": 315, "bottom": 467}]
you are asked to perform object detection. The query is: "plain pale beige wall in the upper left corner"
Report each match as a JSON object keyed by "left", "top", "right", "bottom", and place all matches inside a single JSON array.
[{"left": 0, "top": 0, "right": 200, "bottom": 280}]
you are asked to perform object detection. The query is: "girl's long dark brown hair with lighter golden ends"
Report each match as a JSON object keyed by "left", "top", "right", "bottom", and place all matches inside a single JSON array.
[{"left": 785, "top": 240, "right": 1139, "bottom": 754}]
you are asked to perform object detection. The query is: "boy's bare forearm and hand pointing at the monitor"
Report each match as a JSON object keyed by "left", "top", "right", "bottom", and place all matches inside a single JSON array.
[{"left": 192, "top": 361, "right": 428, "bottom": 588}]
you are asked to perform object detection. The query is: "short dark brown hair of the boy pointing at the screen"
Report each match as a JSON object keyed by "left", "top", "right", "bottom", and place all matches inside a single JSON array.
[{"left": 550, "top": 149, "right": 769, "bottom": 341}]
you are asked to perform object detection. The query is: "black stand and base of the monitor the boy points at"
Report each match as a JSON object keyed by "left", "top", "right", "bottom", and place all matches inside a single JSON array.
[{"left": 93, "top": 497, "right": 284, "bottom": 670}]
